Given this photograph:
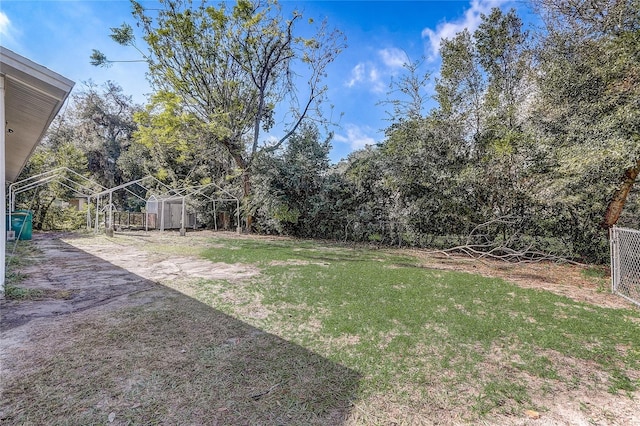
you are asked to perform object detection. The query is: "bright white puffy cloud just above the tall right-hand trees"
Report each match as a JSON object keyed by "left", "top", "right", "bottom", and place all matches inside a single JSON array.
[{"left": 422, "top": 0, "right": 507, "bottom": 60}]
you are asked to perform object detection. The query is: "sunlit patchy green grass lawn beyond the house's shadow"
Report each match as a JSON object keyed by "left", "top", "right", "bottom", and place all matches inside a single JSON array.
[{"left": 190, "top": 239, "right": 640, "bottom": 421}]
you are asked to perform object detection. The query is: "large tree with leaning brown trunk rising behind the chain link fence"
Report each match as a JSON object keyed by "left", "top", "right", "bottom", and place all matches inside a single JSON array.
[{"left": 537, "top": 0, "right": 640, "bottom": 228}]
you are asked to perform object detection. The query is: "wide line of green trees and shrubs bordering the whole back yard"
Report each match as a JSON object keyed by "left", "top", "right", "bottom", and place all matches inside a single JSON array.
[{"left": 16, "top": 0, "right": 640, "bottom": 262}]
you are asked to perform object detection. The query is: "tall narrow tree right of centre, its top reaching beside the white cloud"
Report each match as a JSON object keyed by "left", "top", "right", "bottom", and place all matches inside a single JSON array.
[{"left": 471, "top": 8, "right": 535, "bottom": 236}]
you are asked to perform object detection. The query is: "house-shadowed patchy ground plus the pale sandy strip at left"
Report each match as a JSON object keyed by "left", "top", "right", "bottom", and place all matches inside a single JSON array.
[{"left": 0, "top": 234, "right": 359, "bottom": 425}]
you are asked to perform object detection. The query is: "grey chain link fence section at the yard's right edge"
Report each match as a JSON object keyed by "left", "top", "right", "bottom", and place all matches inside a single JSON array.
[{"left": 610, "top": 227, "right": 640, "bottom": 306}]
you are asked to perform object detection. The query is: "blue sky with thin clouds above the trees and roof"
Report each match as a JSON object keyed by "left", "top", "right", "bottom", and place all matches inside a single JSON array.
[{"left": 0, "top": 0, "right": 525, "bottom": 161}]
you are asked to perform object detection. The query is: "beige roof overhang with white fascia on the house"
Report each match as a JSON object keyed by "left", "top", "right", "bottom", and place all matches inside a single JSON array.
[{"left": 0, "top": 46, "right": 74, "bottom": 183}]
